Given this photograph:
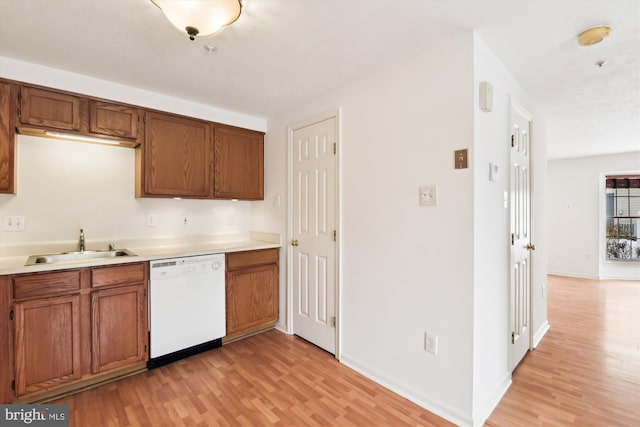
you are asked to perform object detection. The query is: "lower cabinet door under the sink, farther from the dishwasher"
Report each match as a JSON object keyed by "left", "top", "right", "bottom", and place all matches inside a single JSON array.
[{"left": 14, "top": 294, "right": 81, "bottom": 397}]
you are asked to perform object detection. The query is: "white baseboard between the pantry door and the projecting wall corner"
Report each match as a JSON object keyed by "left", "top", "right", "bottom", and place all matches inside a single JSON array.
[{"left": 340, "top": 352, "right": 473, "bottom": 427}]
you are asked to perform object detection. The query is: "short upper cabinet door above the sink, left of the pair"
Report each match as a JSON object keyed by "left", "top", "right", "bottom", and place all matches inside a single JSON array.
[{"left": 20, "top": 86, "right": 81, "bottom": 131}]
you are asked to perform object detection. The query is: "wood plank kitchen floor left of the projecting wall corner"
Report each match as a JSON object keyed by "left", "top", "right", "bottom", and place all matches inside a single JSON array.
[{"left": 55, "top": 330, "right": 452, "bottom": 427}]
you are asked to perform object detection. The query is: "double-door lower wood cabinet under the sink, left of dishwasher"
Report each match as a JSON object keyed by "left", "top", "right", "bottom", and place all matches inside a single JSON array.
[{"left": 5, "top": 263, "right": 148, "bottom": 403}]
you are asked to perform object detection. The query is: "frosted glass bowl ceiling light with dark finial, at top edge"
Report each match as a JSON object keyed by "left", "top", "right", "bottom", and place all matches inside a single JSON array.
[{"left": 151, "top": 0, "right": 242, "bottom": 40}]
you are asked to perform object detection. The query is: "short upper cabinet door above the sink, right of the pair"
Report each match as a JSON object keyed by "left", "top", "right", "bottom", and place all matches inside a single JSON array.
[{"left": 89, "top": 100, "right": 138, "bottom": 140}]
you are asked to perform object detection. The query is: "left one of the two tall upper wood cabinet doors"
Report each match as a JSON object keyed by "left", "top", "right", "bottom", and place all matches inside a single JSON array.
[{"left": 143, "top": 113, "right": 213, "bottom": 198}]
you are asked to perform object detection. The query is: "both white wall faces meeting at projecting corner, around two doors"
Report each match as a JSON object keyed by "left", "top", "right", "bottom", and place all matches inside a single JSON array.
[{"left": 253, "top": 32, "right": 546, "bottom": 425}]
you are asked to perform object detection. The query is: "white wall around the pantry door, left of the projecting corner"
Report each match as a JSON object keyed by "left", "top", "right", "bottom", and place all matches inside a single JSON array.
[{"left": 253, "top": 33, "right": 473, "bottom": 425}]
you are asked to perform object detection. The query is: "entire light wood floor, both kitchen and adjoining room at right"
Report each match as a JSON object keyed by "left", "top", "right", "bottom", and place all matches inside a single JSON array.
[{"left": 56, "top": 276, "right": 640, "bottom": 427}]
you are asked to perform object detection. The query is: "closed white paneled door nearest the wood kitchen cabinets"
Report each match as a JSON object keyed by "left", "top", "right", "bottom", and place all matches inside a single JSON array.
[{"left": 290, "top": 117, "right": 337, "bottom": 354}]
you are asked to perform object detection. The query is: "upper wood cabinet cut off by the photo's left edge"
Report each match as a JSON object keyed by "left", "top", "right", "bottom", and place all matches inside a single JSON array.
[{"left": 0, "top": 81, "right": 16, "bottom": 194}]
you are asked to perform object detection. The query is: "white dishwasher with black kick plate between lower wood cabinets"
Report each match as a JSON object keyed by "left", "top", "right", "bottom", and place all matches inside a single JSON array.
[{"left": 147, "top": 254, "right": 226, "bottom": 368}]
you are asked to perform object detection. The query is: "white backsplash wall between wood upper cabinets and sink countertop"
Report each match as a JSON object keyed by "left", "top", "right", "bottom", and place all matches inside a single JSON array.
[{"left": 0, "top": 136, "right": 251, "bottom": 254}]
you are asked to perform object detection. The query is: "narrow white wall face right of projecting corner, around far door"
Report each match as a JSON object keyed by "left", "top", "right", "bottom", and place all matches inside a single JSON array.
[{"left": 473, "top": 36, "right": 547, "bottom": 423}]
